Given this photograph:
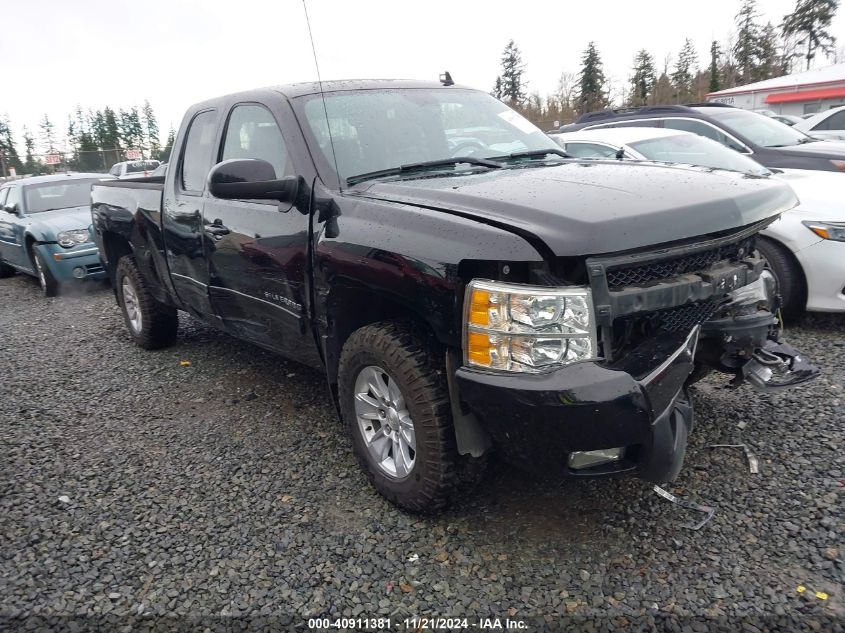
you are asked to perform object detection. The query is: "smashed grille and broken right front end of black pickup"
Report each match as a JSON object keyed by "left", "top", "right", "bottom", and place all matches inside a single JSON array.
[{"left": 587, "top": 222, "right": 818, "bottom": 391}]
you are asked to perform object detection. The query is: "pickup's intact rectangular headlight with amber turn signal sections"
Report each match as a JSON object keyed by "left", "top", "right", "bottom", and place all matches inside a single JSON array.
[{"left": 464, "top": 279, "right": 597, "bottom": 373}]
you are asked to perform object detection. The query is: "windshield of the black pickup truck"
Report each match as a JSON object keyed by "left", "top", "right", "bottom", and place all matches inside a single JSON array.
[{"left": 297, "top": 88, "right": 560, "bottom": 180}]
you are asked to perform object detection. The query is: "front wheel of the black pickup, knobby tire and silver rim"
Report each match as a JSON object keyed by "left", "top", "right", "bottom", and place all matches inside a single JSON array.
[{"left": 338, "top": 323, "right": 459, "bottom": 513}]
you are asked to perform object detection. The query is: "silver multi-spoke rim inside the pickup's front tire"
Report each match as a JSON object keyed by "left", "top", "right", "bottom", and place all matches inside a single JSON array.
[{"left": 355, "top": 365, "right": 417, "bottom": 479}]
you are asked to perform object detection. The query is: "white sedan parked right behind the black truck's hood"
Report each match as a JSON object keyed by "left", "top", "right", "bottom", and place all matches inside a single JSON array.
[{"left": 549, "top": 127, "right": 845, "bottom": 314}]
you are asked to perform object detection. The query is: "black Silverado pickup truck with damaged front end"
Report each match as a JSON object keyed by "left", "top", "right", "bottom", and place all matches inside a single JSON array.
[{"left": 92, "top": 81, "right": 817, "bottom": 511}]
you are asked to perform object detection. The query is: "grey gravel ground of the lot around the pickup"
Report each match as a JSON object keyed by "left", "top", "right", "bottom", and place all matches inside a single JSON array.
[{"left": 0, "top": 276, "right": 845, "bottom": 631}]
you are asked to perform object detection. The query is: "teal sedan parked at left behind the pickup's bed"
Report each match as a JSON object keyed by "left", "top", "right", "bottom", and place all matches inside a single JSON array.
[{"left": 0, "top": 174, "right": 111, "bottom": 297}]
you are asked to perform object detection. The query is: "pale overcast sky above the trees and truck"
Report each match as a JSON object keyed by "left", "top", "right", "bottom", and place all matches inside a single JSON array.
[{"left": 0, "top": 0, "right": 845, "bottom": 151}]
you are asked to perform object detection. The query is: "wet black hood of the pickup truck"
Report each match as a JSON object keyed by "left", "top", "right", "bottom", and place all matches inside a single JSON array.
[{"left": 349, "top": 160, "right": 797, "bottom": 256}]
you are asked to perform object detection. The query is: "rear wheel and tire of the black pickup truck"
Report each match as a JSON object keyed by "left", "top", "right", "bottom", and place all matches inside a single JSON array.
[{"left": 115, "top": 255, "right": 179, "bottom": 349}]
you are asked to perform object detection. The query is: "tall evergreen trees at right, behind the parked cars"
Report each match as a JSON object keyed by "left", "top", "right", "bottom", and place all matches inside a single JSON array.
[{"left": 492, "top": 0, "right": 840, "bottom": 127}]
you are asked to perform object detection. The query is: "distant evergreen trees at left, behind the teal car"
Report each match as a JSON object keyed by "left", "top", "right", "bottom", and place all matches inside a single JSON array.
[{"left": 0, "top": 100, "right": 176, "bottom": 176}]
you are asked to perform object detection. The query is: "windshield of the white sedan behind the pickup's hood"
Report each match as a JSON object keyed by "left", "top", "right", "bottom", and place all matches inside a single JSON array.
[{"left": 628, "top": 134, "right": 769, "bottom": 176}]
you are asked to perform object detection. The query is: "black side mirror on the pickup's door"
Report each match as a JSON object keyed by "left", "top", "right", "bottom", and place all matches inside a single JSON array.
[{"left": 208, "top": 158, "right": 299, "bottom": 202}]
